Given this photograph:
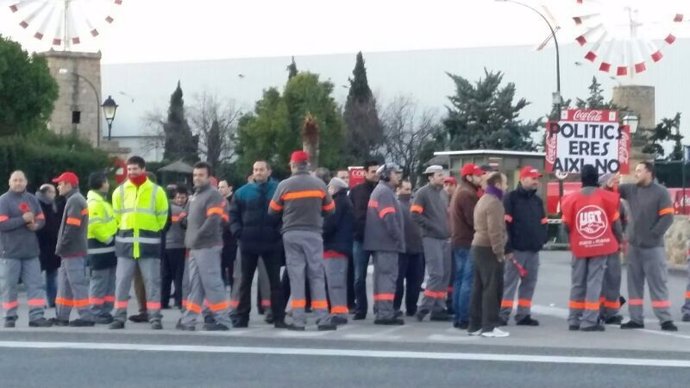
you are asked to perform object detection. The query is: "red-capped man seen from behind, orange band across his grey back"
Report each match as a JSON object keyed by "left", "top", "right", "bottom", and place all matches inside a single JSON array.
[{"left": 268, "top": 151, "right": 336, "bottom": 331}]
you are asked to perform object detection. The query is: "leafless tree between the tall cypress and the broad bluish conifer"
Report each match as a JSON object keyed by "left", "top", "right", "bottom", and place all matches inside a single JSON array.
[{"left": 382, "top": 96, "right": 439, "bottom": 183}]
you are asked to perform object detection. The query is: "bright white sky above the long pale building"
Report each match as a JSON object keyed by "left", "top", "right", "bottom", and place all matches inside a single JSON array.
[{"left": 0, "top": 0, "right": 690, "bottom": 64}]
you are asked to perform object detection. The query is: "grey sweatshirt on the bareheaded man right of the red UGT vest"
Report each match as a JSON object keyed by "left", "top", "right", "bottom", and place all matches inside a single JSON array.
[{"left": 618, "top": 183, "right": 673, "bottom": 248}]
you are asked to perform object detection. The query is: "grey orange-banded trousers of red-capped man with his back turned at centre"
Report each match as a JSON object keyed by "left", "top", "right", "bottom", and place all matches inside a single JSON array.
[{"left": 283, "top": 230, "right": 330, "bottom": 327}]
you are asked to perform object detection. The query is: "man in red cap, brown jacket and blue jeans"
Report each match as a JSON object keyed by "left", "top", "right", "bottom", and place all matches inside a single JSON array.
[{"left": 450, "top": 163, "right": 484, "bottom": 330}]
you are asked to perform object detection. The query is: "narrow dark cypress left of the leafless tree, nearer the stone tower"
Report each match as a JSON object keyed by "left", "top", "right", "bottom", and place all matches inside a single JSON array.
[{"left": 163, "top": 81, "right": 199, "bottom": 163}]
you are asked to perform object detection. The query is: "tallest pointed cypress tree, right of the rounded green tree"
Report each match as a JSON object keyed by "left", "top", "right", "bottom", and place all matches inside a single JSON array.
[{"left": 343, "top": 51, "right": 384, "bottom": 163}]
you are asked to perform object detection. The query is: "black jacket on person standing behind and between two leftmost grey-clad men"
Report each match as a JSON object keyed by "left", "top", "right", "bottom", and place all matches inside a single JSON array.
[{"left": 36, "top": 195, "right": 65, "bottom": 272}]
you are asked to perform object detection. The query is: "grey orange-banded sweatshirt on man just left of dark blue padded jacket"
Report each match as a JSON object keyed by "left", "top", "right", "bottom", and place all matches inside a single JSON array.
[{"left": 184, "top": 185, "right": 228, "bottom": 249}]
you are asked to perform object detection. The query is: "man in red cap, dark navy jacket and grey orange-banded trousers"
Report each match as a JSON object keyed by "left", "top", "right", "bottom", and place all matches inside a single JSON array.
[{"left": 500, "top": 166, "right": 547, "bottom": 326}]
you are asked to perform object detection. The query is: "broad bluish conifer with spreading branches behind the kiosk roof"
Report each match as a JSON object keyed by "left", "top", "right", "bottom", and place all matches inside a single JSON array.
[{"left": 443, "top": 69, "right": 540, "bottom": 151}]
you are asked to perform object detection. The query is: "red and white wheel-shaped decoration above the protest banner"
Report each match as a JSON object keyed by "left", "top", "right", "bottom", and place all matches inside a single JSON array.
[{"left": 571, "top": 0, "right": 687, "bottom": 77}]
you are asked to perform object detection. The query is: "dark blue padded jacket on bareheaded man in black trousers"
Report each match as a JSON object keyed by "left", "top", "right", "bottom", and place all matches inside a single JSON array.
[{"left": 230, "top": 179, "right": 282, "bottom": 254}]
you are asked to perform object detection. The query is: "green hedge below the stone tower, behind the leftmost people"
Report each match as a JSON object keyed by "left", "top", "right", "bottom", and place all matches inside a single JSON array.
[{"left": 0, "top": 131, "right": 113, "bottom": 192}]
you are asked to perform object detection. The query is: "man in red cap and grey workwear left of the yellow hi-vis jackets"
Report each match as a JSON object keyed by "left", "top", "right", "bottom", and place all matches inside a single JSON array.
[{"left": 53, "top": 171, "right": 94, "bottom": 327}]
